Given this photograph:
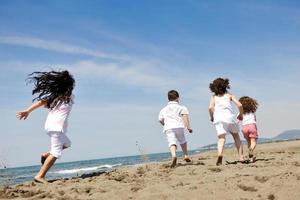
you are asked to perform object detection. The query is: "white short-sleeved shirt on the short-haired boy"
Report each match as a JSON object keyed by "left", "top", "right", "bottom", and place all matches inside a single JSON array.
[{"left": 158, "top": 101, "right": 189, "bottom": 131}]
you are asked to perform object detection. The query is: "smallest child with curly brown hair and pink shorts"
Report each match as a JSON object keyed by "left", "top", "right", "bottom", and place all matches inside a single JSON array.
[{"left": 239, "top": 96, "right": 258, "bottom": 162}]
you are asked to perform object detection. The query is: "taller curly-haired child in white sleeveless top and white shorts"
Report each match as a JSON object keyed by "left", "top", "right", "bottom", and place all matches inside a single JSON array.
[{"left": 209, "top": 78, "right": 245, "bottom": 165}]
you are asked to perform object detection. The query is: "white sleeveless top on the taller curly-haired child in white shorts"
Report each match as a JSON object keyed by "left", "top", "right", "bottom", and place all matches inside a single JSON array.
[{"left": 213, "top": 94, "right": 236, "bottom": 124}]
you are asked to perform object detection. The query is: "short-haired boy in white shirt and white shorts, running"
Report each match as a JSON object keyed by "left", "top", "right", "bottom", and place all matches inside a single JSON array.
[{"left": 158, "top": 90, "right": 193, "bottom": 168}]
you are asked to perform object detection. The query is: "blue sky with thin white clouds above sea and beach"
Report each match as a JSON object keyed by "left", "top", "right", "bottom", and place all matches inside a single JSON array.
[{"left": 0, "top": 0, "right": 300, "bottom": 166}]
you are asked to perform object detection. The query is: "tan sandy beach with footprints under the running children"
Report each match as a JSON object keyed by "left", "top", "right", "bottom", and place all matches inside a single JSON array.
[{"left": 0, "top": 140, "right": 300, "bottom": 200}]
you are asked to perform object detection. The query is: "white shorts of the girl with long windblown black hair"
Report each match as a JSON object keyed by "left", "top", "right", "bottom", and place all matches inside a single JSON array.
[{"left": 48, "top": 131, "right": 71, "bottom": 158}]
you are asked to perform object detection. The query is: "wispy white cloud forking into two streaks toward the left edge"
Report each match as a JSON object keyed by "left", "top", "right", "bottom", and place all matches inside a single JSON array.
[{"left": 0, "top": 36, "right": 193, "bottom": 92}]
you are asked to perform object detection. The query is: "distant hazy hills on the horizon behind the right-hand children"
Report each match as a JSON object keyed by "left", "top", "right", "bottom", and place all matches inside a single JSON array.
[{"left": 199, "top": 129, "right": 300, "bottom": 150}]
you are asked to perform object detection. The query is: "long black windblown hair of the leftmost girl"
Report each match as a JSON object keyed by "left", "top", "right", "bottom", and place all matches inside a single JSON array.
[{"left": 27, "top": 70, "right": 75, "bottom": 109}]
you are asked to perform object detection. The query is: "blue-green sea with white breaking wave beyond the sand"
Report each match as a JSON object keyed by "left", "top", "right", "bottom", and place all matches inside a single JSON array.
[{"left": 0, "top": 148, "right": 211, "bottom": 186}]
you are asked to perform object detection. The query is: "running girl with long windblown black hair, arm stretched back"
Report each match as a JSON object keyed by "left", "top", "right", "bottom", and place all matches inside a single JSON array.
[{"left": 17, "top": 71, "right": 75, "bottom": 183}]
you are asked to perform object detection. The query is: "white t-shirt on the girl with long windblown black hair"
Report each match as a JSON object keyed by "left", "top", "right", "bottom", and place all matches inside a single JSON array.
[{"left": 45, "top": 95, "right": 74, "bottom": 133}]
